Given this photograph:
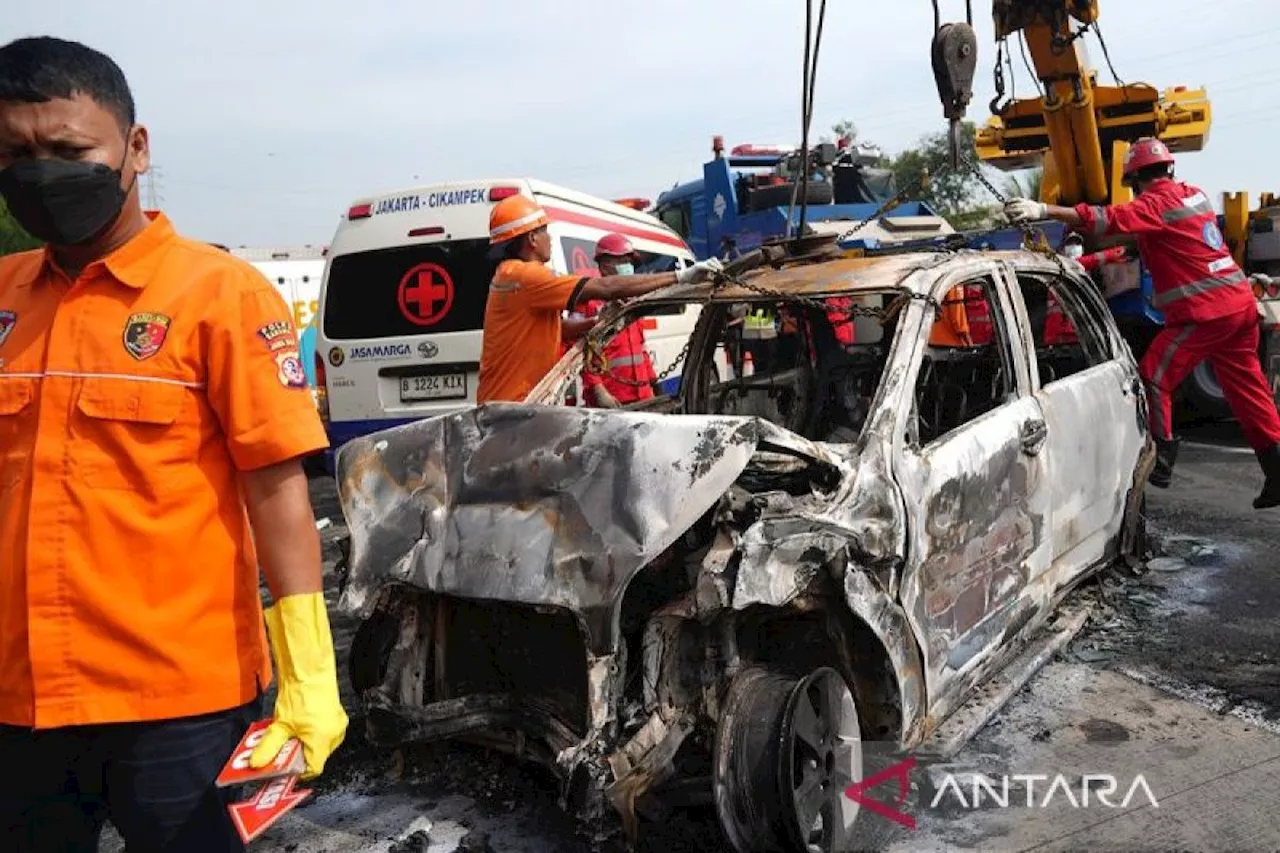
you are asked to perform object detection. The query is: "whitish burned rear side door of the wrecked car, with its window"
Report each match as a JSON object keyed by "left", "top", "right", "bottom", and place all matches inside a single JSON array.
[{"left": 1005, "top": 264, "right": 1147, "bottom": 589}]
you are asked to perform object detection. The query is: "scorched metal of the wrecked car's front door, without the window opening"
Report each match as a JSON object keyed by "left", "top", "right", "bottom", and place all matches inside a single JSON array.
[{"left": 893, "top": 265, "right": 1052, "bottom": 720}]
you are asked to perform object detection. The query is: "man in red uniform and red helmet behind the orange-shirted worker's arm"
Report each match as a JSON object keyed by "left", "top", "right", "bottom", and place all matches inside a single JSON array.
[{"left": 571, "top": 233, "right": 658, "bottom": 409}]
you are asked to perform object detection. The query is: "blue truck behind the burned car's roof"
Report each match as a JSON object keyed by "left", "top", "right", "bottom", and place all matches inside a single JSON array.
[{"left": 650, "top": 136, "right": 955, "bottom": 260}]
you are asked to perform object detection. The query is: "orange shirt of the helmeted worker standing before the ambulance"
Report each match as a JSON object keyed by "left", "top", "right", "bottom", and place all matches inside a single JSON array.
[{"left": 476, "top": 260, "right": 586, "bottom": 403}]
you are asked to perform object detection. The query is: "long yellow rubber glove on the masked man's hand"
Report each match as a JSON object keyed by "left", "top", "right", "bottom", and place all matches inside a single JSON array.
[{"left": 248, "top": 593, "right": 347, "bottom": 779}]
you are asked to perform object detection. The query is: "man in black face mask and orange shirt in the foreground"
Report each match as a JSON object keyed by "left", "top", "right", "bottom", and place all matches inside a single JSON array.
[{"left": 0, "top": 38, "right": 347, "bottom": 853}]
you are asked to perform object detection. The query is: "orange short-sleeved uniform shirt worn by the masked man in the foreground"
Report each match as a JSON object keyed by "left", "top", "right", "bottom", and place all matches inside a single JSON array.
[{"left": 0, "top": 214, "right": 328, "bottom": 727}]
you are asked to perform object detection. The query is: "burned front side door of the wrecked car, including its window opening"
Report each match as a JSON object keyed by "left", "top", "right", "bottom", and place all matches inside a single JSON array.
[{"left": 893, "top": 261, "right": 1051, "bottom": 719}]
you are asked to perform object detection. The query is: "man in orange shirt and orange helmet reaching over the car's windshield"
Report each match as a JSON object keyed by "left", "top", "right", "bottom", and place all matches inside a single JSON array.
[{"left": 476, "top": 196, "right": 723, "bottom": 403}]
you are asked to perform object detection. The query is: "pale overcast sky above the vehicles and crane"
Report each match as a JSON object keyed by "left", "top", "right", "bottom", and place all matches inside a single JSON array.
[{"left": 0, "top": 0, "right": 1280, "bottom": 245}]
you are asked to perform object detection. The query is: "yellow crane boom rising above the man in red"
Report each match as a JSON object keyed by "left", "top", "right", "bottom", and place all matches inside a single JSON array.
[{"left": 977, "top": 0, "right": 1211, "bottom": 205}]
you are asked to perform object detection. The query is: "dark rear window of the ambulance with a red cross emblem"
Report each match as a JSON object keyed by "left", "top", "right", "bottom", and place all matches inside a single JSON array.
[{"left": 324, "top": 238, "right": 498, "bottom": 341}]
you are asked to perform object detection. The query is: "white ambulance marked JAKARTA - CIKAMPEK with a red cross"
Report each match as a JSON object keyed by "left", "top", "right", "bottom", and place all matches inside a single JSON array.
[{"left": 315, "top": 178, "right": 698, "bottom": 461}]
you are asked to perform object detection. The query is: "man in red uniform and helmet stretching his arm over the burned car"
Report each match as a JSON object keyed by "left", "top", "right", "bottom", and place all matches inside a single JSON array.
[{"left": 1005, "top": 138, "right": 1280, "bottom": 510}]
